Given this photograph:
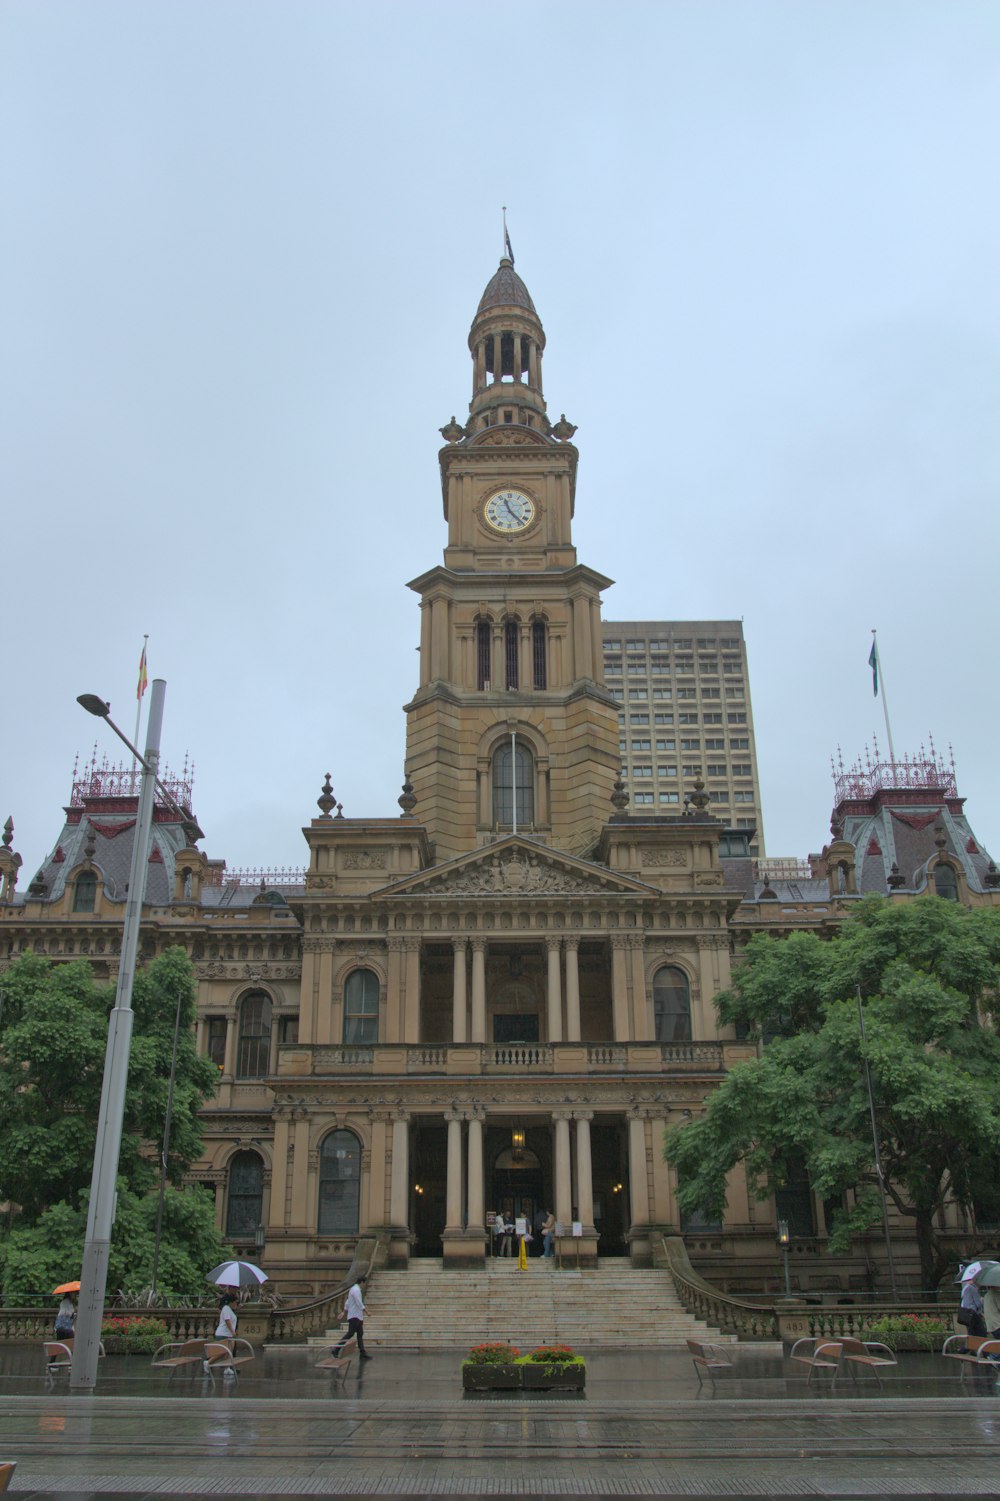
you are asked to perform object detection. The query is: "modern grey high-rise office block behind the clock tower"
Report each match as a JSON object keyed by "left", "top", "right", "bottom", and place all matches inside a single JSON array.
[{"left": 604, "top": 620, "right": 764, "bottom": 857}]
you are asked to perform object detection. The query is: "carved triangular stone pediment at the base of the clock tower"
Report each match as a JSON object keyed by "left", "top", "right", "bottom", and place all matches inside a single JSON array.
[{"left": 372, "top": 835, "right": 662, "bottom": 901}]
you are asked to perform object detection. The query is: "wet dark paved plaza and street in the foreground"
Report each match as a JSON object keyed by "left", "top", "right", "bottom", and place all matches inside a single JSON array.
[{"left": 0, "top": 1346, "right": 1000, "bottom": 1501}]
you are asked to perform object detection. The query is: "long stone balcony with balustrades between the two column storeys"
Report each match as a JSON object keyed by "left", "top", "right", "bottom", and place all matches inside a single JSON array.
[{"left": 278, "top": 1042, "right": 744, "bottom": 1078}]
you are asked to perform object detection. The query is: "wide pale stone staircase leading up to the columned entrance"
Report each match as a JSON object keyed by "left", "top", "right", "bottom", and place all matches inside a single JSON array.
[{"left": 309, "top": 1256, "right": 733, "bottom": 1352}]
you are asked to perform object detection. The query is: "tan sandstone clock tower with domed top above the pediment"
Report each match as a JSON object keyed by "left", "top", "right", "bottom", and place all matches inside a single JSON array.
[{"left": 405, "top": 257, "right": 620, "bottom": 862}]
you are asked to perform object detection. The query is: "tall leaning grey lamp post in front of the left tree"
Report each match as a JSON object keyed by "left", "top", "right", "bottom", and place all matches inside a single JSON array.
[{"left": 69, "top": 677, "right": 167, "bottom": 1388}]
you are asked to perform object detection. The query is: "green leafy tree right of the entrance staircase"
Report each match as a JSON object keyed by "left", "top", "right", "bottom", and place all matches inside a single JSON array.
[{"left": 665, "top": 896, "right": 1000, "bottom": 1286}]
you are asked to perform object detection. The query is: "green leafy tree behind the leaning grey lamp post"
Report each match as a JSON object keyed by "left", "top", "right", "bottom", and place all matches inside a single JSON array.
[{"left": 0, "top": 949, "right": 219, "bottom": 1300}]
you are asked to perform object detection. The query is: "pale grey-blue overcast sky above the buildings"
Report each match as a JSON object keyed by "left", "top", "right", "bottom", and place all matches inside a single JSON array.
[{"left": 0, "top": 0, "right": 1000, "bottom": 886}]
